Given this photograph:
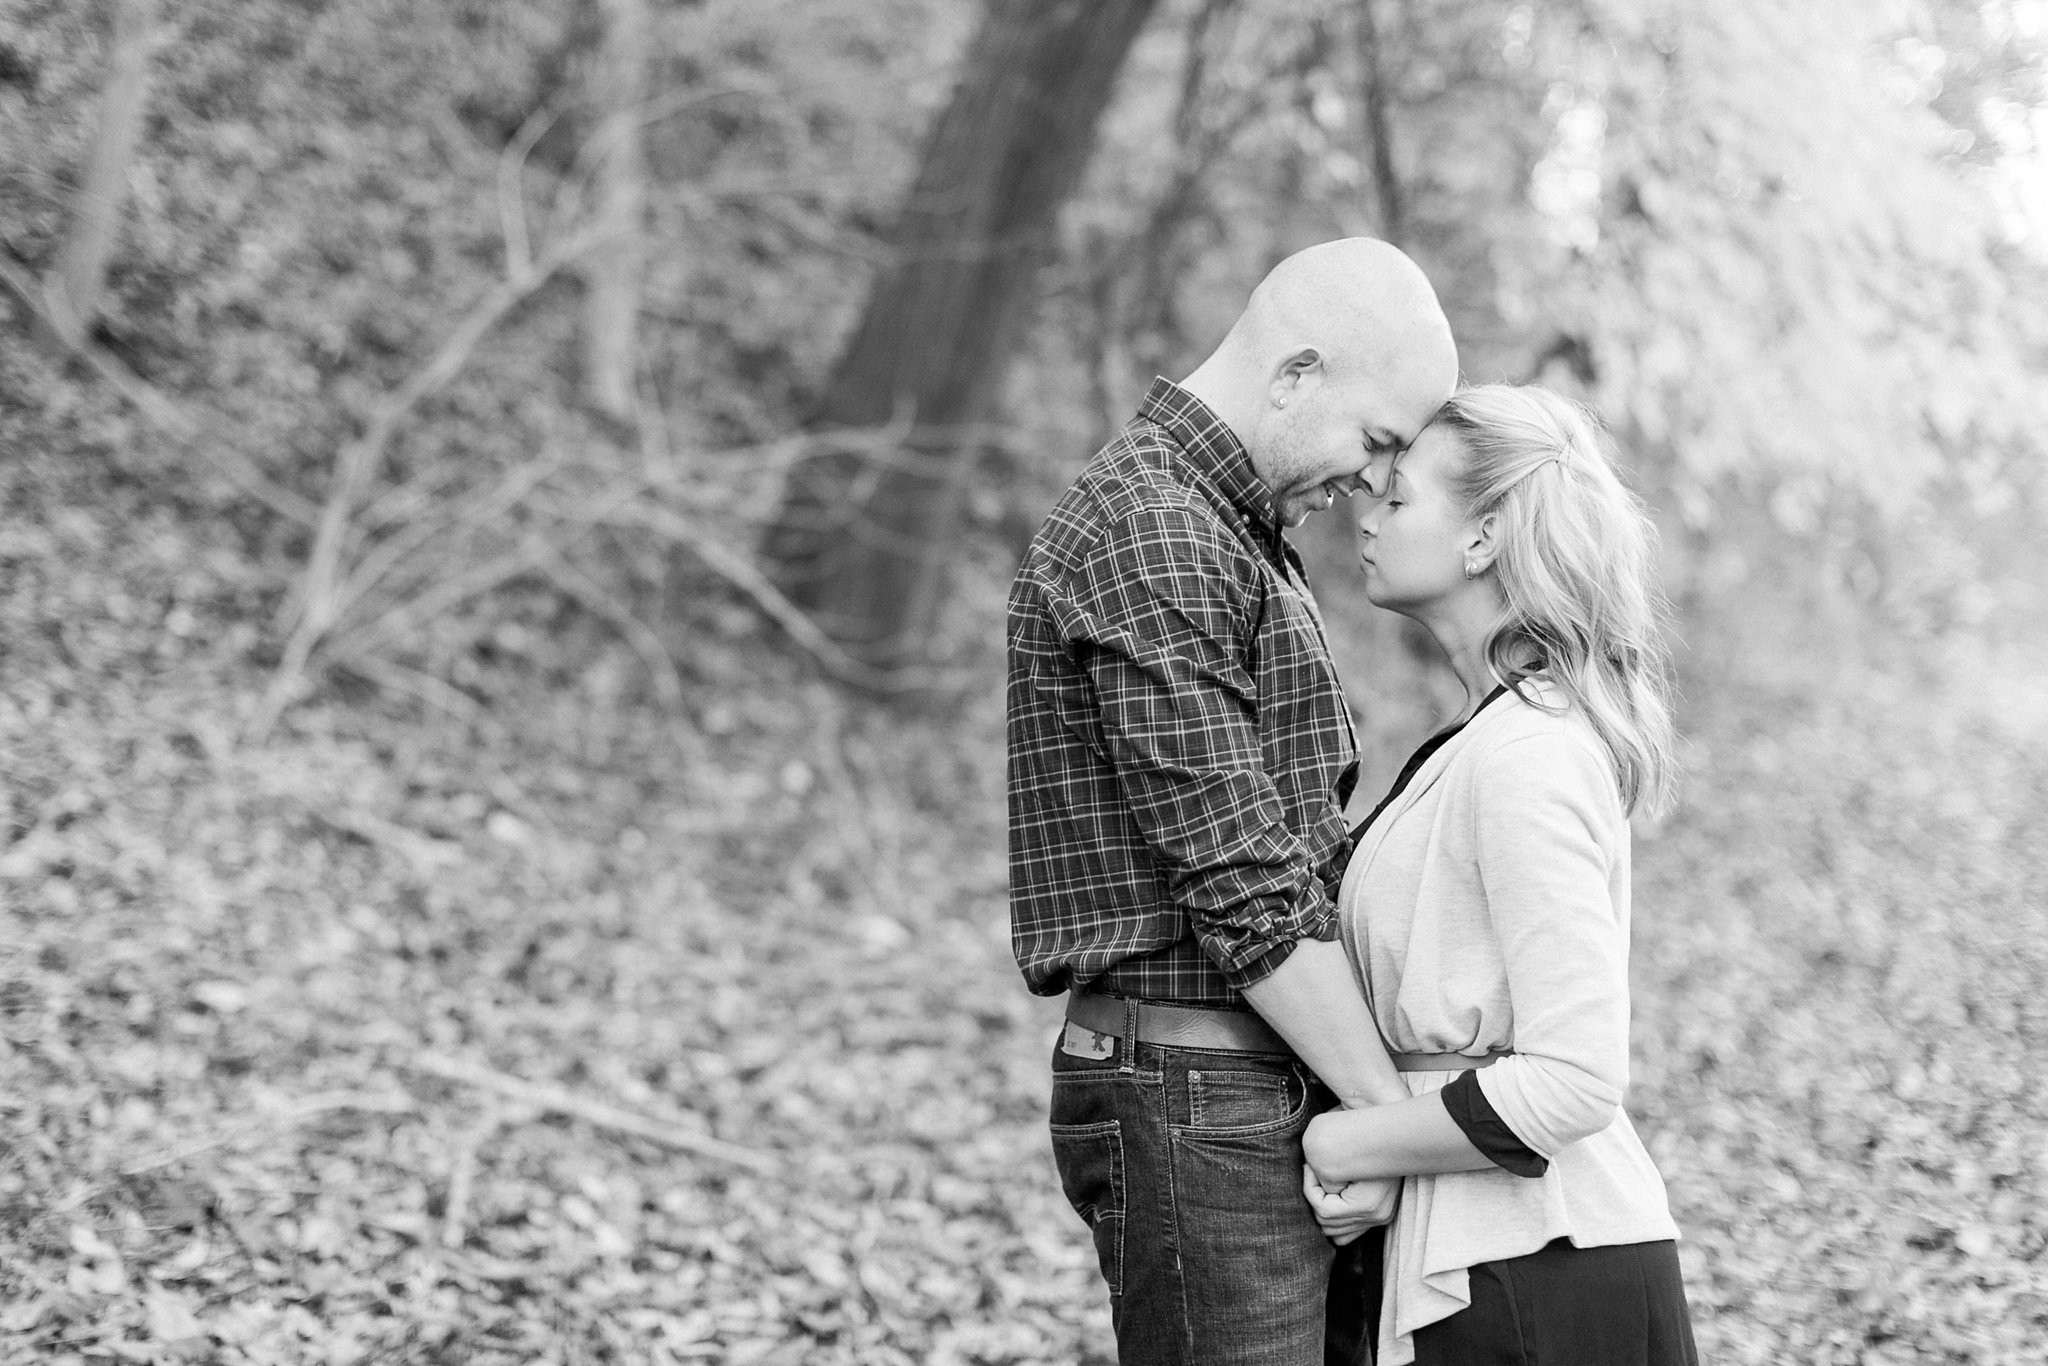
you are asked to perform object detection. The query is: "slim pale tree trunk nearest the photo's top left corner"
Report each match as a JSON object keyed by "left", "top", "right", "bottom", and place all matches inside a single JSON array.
[{"left": 43, "top": 0, "right": 156, "bottom": 346}]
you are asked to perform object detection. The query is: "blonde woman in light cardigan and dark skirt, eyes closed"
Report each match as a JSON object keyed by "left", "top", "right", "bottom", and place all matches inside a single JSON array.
[{"left": 1303, "top": 385, "right": 1698, "bottom": 1366}]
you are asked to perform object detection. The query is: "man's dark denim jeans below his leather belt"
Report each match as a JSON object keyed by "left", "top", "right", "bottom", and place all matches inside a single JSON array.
[{"left": 1053, "top": 1040, "right": 1378, "bottom": 1366}]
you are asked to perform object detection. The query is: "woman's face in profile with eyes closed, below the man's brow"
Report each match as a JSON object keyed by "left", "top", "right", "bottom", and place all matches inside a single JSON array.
[{"left": 1358, "top": 426, "right": 1477, "bottom": 614}]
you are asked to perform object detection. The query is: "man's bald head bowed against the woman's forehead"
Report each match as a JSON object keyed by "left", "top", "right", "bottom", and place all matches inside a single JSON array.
[{"left": 1182, "top": 238, "right": 1458, "bottom": 524}]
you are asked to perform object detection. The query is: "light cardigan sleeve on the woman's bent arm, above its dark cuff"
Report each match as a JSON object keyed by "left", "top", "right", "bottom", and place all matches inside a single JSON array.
[{"left": 1475, "top": 729, "right": 1628, "bottom": 1157}]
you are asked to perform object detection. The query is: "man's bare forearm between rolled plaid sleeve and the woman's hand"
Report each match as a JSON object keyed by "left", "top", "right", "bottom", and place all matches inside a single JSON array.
[{"left": 1245, "top": 940, "right": 1407, "bottom": 1106}]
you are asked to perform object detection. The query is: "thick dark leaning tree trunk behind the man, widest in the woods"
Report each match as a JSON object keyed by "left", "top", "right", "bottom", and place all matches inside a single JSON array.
[{"left": 768, "top": 0, "right": 1153, "bottom": 670}]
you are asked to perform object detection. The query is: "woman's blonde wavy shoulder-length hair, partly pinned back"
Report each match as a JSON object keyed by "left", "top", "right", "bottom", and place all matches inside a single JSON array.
[{"left": 1436, "top": 385, "right": 1675, "bottom": 813}]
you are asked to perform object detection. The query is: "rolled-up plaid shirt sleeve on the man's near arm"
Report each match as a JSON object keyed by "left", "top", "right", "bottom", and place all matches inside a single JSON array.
[{"left": 1049, "top": 508, "right": 1337, "bottom": 989}]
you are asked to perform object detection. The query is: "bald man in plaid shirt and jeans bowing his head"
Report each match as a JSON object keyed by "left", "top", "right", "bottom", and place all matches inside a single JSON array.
[{"left": 1010, "top": 238, "right": 1458, "bottom": 1366}]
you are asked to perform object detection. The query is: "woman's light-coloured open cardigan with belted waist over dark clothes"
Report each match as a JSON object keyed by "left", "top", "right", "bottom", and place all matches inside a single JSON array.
[{"left": 1337, "top": 684, "right": 1677, "bottom": 1366}]
